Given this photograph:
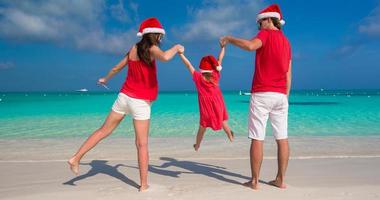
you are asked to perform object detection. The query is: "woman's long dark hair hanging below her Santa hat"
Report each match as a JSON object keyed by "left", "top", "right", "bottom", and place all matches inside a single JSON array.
[{"left": 136, "top": 33, "right": 162, "bottom": 66}]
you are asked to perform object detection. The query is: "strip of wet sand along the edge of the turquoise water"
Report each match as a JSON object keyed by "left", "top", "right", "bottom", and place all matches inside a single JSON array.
[{"left": 0, "top": 134, "right": 380, "bottom": 162}]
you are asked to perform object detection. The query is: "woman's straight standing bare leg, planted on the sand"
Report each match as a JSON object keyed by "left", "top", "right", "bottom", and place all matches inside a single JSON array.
[{"left": 133, "top": 119, "right": 150, "bottom": 192}]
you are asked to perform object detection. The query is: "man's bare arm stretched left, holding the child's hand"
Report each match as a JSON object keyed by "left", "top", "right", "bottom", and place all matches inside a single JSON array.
[{"left": 220, "top": 36, "right": 263, "bottom": 51}]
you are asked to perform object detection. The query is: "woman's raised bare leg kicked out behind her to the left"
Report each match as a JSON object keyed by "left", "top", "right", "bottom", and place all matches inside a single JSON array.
[{"left": 68, "top": 111, "right": 124, "bottom": 175}]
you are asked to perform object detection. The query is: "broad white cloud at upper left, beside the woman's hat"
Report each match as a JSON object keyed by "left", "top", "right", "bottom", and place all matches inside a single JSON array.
[{"left": 0, "top": 0, "right": 137, "bottom": 54}]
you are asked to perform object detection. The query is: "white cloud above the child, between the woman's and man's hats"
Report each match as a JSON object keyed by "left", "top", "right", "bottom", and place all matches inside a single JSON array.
[{"left": 173, "top": 0, "right": 264, "bottom": 41}]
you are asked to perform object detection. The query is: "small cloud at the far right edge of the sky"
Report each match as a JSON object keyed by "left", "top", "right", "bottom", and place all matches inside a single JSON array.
[{"left": 359, "top": 6, "right": 380, "bottom": 37}]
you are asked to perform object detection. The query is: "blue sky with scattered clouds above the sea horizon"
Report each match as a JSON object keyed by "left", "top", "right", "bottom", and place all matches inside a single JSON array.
[{"left": 0, "top": 0, "right": 380, "bottom": 91}]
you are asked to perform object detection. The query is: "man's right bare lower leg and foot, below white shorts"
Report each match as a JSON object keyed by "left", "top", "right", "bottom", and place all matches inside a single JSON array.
[{"left": 269, "top": 139, "right": 289, "bottom": 189}]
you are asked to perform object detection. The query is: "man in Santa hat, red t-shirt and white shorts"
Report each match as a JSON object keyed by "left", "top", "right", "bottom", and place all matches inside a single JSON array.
[{"left": 220, "top": 4, "right": 291, "bottom": 189}]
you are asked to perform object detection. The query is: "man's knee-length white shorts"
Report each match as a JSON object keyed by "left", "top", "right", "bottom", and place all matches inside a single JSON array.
[{"left": 248, "top": 92, "right": 289, "bottom": 140}]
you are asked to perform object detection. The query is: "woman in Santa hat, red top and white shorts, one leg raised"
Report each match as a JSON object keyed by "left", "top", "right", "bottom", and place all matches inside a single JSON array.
[{"left": 68, "top": 18, "right": 184, "bottom": 191}]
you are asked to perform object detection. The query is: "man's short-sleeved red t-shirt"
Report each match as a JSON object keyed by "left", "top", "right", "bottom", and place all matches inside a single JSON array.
[{"left": 251, "top": 30, "right": 292, "bottom": 94}]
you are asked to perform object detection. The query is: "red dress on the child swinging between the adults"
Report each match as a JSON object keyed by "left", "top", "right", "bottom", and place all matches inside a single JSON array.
[{"left": 193, "top": 71, "right": 228, "bottom": 131}]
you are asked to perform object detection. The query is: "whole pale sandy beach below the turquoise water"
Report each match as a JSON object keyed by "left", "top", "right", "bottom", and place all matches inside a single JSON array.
[{"left": 0, "top": 136, "right": 380, "bottom": 200}]
